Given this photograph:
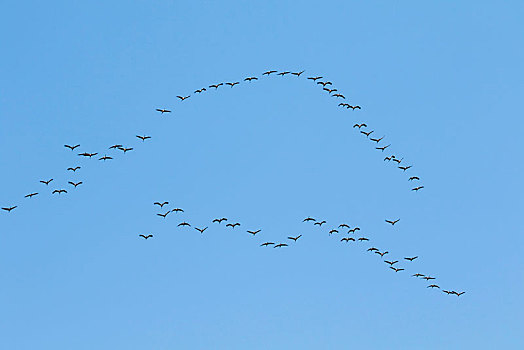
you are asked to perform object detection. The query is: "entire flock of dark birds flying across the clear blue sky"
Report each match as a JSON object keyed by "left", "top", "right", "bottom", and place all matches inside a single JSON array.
[{"left": 1, "top": 70, "right": 465, "bottom": 296}]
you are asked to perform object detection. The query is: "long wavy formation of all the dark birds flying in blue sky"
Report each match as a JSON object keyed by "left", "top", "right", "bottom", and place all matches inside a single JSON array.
[{"left": 1, "top": 70, "right": 465, "bottom": 296}]
